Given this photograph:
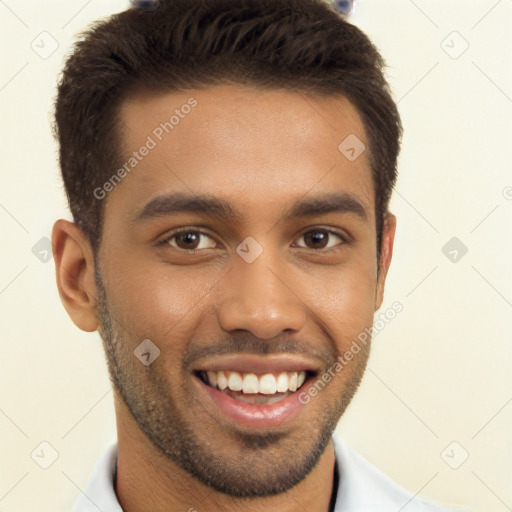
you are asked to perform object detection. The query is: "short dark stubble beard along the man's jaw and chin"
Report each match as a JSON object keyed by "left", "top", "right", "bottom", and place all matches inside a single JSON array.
[{"left": 95, "top": 266, "right": 368, "bottom": 497}]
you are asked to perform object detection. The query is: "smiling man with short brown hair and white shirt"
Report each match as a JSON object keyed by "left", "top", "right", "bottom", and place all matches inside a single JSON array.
[{"left": 53, "top": 0, "right": 460, "bottom": 512}]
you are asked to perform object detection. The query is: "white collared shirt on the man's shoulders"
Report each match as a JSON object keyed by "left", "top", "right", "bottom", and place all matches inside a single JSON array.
[{"left": 71, "top": 436, "right": 464, "bottom": 512}]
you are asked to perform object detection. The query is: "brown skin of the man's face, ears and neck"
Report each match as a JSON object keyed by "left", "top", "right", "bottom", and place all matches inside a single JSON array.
[{"left": 53, "top": 85, "right": 396, "bottom": 512}]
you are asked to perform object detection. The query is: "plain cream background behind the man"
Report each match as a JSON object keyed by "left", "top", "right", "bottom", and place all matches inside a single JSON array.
[{"left": 0, "top": 0, "right": 512, "bottom": 512}]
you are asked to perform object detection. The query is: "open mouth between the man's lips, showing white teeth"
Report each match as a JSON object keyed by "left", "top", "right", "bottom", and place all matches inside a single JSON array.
[{"left": 194, "top": 370, "right": 316, "bottom": 404}]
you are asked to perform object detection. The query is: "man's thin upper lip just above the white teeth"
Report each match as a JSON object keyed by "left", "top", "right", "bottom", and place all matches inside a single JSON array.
[{"left": 194, "top": 354, "right": 320, "bottom": 373}]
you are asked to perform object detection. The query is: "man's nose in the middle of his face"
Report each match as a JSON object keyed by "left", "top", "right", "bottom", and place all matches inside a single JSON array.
[{"left": 217, "top": 251, "right": 306, "bottom": 339}]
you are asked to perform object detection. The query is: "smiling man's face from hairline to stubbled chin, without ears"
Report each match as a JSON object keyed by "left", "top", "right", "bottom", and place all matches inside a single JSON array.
[{"left": 96, "top": 85, "right": 390, "bottom": 496}]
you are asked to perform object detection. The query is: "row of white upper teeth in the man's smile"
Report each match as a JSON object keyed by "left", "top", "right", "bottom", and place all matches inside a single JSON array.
[{"left": 203, "top": 370, "right": 306, "bottom": 395}]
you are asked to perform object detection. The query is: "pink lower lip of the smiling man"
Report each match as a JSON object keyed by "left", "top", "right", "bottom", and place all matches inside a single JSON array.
[{"left": 195, "top": 378, "right": 310, "bottom": 428}]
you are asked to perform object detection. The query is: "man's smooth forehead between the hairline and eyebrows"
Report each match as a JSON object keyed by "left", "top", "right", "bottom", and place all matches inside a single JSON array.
[{"left": 107, "top": 85, "right": 374, "bottom": 224}]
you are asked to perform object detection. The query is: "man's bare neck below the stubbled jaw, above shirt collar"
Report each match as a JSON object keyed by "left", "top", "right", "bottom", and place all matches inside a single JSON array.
[{"left": 115, "top": 404, "right": 336, "bottom": 512}]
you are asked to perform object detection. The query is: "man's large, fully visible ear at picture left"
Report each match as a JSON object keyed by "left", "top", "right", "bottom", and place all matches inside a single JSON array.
[{"left": 52, "top": 219, "right": 98, "bottom": 332}]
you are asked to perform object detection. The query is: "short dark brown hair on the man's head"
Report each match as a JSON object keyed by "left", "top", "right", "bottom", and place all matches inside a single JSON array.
[{"left": 54, "top": 0, "right": 402, "bottom": 254}]
